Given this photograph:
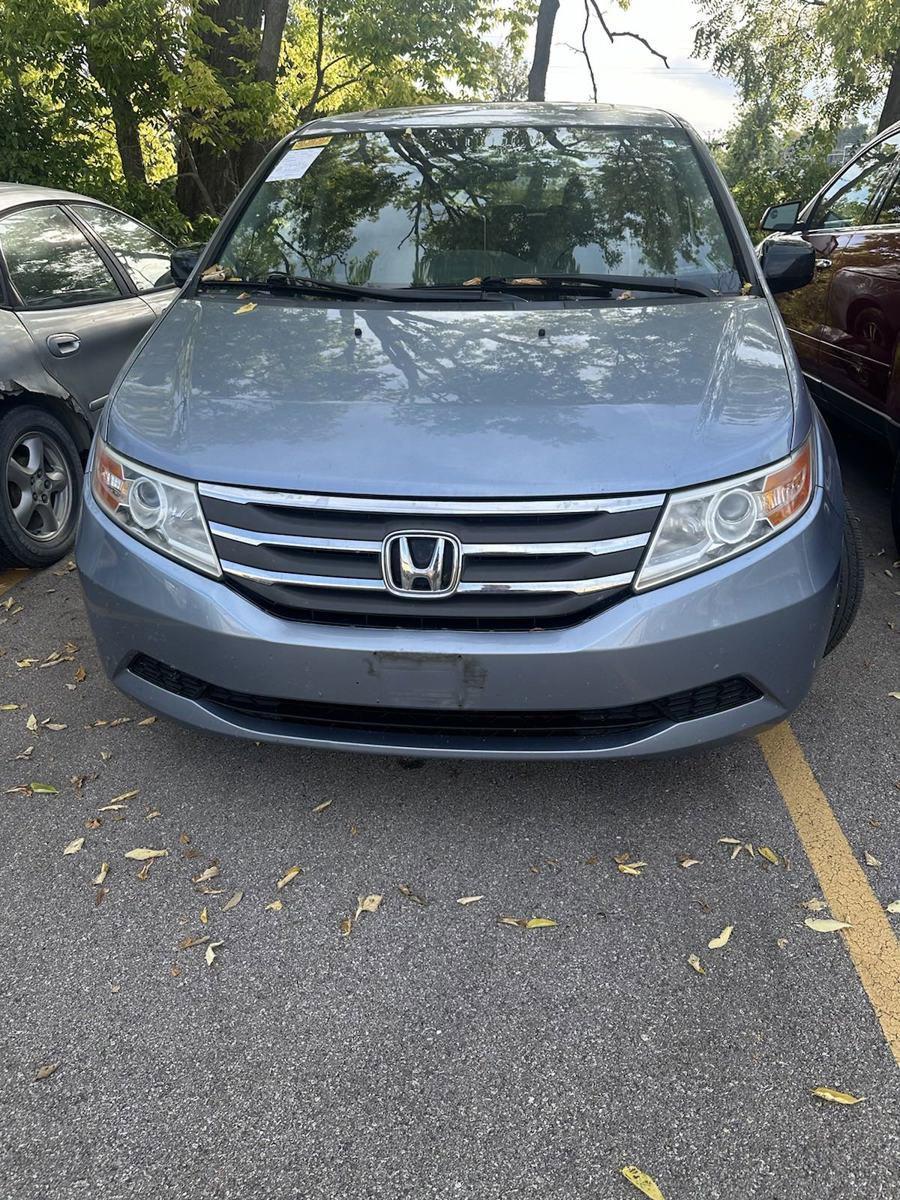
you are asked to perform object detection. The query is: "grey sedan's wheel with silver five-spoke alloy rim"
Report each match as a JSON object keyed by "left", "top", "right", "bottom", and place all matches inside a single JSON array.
[{"left": 0, "top": 404, "right": 84, "bottom": 569}]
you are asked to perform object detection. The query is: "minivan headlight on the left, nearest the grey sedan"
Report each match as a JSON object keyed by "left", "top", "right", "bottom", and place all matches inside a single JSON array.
[{"left": 91, "top": 439, "right": 222, "bottom": 576}]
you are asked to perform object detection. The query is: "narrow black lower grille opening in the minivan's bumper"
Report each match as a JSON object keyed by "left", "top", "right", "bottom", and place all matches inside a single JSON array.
[{"left": 128, "top": 654, "right": 762, "bottom": 739}]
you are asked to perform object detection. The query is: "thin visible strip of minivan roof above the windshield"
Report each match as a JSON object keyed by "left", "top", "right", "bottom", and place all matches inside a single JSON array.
[{"left": 302, "top": 101, "right": 680, "bottom": 133}]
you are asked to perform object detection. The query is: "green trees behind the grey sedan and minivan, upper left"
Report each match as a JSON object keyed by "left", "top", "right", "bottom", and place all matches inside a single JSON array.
[{"left": 0, "top": 0, "right": 533, "bottom": 235}]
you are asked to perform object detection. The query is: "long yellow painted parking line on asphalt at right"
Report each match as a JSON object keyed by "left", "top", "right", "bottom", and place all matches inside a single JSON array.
[{"left": 758, "top": 721, "right": 900, "bottom": 1066}]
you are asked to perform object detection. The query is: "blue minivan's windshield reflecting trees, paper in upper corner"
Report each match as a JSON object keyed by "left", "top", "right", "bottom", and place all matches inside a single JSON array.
[{"left": 214, "top": 126, "right": 742, "bottom": 299}]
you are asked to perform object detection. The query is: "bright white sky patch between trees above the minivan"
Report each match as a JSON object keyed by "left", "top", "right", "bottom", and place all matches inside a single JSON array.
[{"left": 527, "top": 0, "right": 736, "bottom": 138}]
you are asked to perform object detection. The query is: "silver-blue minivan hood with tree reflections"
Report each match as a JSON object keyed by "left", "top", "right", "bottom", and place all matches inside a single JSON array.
[{"left": 104, "top": 295, "right": 794, "bottom": 497}]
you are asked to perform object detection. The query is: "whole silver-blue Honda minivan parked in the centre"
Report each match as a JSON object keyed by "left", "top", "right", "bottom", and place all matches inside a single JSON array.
[{"left": 78, "top": 104, "right": 860, "bottom": 758}]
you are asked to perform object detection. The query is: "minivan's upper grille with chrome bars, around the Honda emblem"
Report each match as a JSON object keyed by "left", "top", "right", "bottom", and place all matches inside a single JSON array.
[{"left": 200, "top": 484, "right": 665, "bottom": 629}]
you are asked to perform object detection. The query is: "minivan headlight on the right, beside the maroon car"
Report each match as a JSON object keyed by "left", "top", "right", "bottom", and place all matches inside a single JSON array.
[{"left": 635, "top": 433, "right": 815, "bottom": 590}]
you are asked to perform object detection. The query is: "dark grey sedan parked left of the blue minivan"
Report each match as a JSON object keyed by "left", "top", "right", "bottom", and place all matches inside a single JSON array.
[{"left": 0, "top": 182, "right": 176, "bottom": 566}]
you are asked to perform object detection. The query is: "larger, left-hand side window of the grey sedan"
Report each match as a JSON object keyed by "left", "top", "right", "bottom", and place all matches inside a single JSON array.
[{"left": 0, "top": 205, "right": 121, "bottom": 308}]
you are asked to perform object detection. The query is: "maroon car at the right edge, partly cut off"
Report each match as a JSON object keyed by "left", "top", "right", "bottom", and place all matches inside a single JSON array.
[{"left": 761, "top": 124, "right": 900, "bottom": 548}]
